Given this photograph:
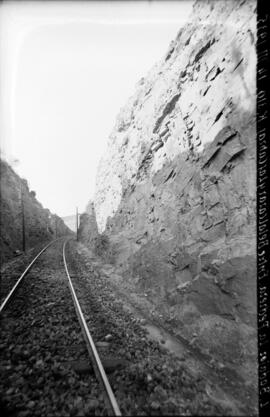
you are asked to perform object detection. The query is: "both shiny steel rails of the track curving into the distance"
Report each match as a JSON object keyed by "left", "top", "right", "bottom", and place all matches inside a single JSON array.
[{"left": 0, "top": 239, "right": 122, "bottom": 416}]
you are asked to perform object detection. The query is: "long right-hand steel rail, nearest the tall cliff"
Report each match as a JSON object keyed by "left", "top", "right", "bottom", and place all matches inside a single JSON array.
[{"left": 63, "top": 241, "right": 122, "bottom": 416}]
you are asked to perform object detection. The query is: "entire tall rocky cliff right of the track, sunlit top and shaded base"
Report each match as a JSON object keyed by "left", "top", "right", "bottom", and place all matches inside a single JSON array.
[{"left": 80, "top": 0, "right": 257, "bottom": 392}]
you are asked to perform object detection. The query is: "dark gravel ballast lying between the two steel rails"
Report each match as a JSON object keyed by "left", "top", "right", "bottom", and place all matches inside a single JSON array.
[{"left": 0, "top": 242, "right": 107, "bottom": 417}]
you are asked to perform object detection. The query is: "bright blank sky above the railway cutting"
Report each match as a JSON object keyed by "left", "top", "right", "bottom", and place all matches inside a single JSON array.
[{"left": 0, "top": 0, "right": 193, "bottom": 216}]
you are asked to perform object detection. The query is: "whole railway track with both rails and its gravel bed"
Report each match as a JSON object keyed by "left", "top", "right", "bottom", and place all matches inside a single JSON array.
[{"left": 0, "top": 240, "right": 236, "bottom": 417}]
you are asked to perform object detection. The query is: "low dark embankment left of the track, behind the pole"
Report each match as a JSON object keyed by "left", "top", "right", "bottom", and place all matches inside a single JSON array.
[{"left": 0, "top": 160, "right": 71, "bottom": 263}]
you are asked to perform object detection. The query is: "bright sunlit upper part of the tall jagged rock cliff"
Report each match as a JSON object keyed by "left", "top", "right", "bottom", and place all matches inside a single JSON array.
[{"left": 95, "top": 1, "right": 256, "bottom": 234}]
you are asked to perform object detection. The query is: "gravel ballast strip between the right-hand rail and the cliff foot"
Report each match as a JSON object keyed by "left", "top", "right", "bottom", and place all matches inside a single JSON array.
[{"left": 63, "top": 241, "right": 231, "bottom": 416}]
